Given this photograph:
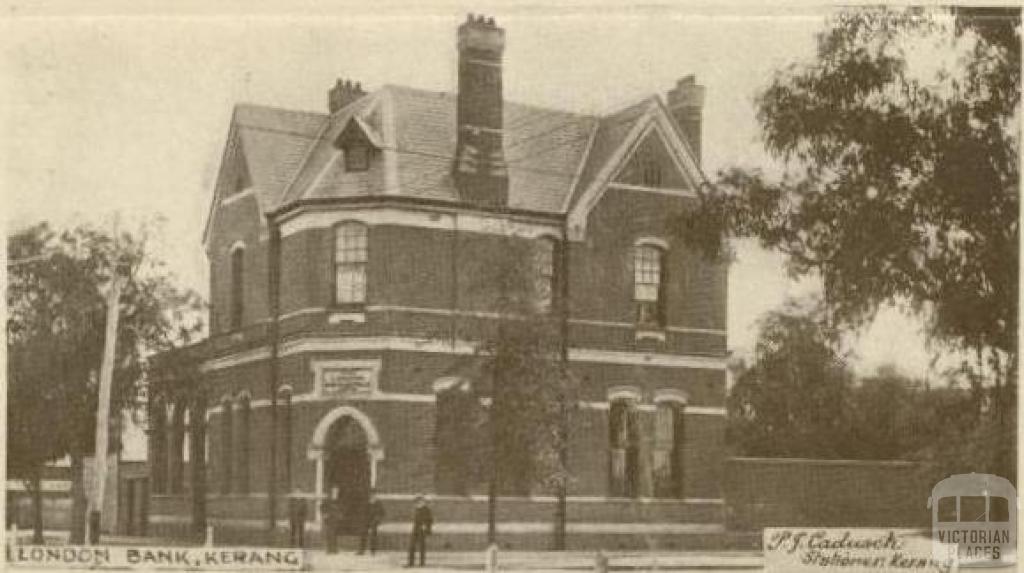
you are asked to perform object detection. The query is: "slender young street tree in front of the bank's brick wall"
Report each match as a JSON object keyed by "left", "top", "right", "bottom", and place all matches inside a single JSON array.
[{"left": 468, "top": 237, "right": 577, "bottom": 548}]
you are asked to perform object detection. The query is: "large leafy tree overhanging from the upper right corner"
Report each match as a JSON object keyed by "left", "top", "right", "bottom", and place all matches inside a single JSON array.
[{"left": 681, "top": 8, "right": 1021, "bottom": 404}]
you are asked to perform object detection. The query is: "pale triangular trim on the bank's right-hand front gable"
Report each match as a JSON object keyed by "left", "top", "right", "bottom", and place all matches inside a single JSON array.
[{"left": 566, "top": 97, "right": 707, "bottom": 240}]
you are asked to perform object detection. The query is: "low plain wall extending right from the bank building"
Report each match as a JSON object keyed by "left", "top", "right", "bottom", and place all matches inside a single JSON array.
[{"left": 723, "top": 457, "right": 934, "bottom": 530}]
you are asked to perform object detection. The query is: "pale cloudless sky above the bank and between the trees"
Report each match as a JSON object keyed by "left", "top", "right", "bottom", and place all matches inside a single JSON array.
[{"left": 0, "top": 2, "right": 946, "bottom": 377}]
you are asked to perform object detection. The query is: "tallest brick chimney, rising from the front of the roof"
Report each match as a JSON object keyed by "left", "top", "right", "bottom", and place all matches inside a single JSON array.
[{"left": 452, "top": 14, "right": 508, "bottom": 207}]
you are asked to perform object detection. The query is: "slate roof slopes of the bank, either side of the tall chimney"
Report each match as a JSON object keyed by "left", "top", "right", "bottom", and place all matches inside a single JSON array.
[{"left": 218, "top": 86, "right": 656, "bottom": 214}]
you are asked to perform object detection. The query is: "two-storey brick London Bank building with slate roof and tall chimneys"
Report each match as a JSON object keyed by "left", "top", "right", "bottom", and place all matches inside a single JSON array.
[{"left": 151, "top": 16, "right": 726, "bottom": 546}]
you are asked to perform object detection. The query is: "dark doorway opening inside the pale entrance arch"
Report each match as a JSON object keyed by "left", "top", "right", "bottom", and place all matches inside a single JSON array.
[{"left": 324, "top": 417, "right": 370, "bottom": 535}]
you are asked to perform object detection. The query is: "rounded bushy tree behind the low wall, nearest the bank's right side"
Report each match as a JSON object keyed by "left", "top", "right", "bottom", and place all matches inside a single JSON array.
[{"left": 728, "top": 302, "right": 853, "bottom": 458}]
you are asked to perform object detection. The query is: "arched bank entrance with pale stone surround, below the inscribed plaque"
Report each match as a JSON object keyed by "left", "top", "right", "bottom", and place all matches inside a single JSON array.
[{"left": 306, "top": 406, "right": 384, "bottom": 524}]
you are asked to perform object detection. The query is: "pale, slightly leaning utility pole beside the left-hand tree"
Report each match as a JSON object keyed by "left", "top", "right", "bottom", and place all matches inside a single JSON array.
[{"left": 88, "top": 264, "right": 123, "bottom": 544}]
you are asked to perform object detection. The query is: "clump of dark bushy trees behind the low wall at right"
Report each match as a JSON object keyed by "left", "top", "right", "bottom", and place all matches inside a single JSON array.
[{"left": 728, "top": 302, "right": 992, "bottom": 460}]
